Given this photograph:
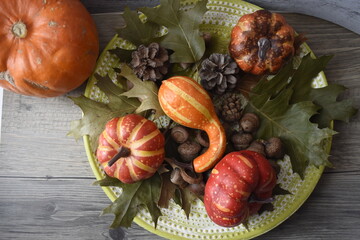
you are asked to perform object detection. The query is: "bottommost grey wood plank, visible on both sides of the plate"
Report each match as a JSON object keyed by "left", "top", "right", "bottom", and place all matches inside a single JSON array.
[{"left": 0, "top": 173, "right": 360, "bottom": 240}]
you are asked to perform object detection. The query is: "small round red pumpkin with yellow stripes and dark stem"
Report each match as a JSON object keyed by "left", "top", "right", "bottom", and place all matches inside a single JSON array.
[{"left": 96, "top": 114, "right": 165, "bottom": 183}]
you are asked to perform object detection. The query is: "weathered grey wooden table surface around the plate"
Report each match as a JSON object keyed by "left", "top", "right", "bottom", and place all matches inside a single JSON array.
[{"left": 0, "top": 0, "right": 360, "bottom": 240}]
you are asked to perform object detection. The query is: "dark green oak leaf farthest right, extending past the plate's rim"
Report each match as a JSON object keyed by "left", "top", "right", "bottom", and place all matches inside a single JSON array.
[{"left": 252, "top": 54, "right": 357, "bottom": 128}]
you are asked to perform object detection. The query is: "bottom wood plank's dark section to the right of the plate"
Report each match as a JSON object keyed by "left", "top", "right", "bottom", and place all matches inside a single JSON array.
[{"left": 256, "top": 173, "right": 360, "bottom": 240}]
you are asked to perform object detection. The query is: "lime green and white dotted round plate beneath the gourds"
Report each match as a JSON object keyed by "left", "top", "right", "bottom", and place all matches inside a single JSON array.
[{"left": 84, "top": 0, "right": 330, "bottom": 240}]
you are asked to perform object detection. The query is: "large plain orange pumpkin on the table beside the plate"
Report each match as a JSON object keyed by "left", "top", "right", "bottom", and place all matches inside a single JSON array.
[{"left": 0, "top": 0, "right": 99, "bottom": 97}]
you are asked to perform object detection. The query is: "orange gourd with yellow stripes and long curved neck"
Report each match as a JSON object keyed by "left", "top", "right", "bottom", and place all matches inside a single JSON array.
[{"left": 158, "top": 76, "right": 226, "bottom": 172}]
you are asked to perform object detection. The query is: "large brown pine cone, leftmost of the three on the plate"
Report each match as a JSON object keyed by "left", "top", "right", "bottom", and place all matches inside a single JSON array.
[{"left": 130, "top": 43, "right": 169, "bottom": 82}]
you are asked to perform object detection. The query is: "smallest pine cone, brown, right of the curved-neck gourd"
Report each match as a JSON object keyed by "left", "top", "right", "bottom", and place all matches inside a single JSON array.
[{"left": 221, "top": 93, "right": 242, "bottom": 122}]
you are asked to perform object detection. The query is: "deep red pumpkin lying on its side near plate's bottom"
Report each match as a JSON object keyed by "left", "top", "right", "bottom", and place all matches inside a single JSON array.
[{"left": 204, "top": 150, "right": 276, "bottom": 227}]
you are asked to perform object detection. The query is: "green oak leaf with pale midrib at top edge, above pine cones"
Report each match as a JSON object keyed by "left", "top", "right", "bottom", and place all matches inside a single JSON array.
[{"left": 140, "top": 0, "right": 207, "bottom": 63}]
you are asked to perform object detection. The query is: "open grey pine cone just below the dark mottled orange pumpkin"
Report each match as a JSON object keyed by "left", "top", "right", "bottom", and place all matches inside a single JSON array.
[{"left": 200, "top": 53, "right": 240, "bottom": 94}]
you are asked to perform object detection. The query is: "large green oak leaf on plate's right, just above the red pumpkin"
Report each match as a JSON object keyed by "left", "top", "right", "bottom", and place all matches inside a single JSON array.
[{"left": 246, "top": 55, "right": 335, "bottom": 177}]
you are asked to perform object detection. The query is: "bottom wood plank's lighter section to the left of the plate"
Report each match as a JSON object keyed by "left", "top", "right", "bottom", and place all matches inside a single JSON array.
[{"left": 0, "top": 177, "right": 162, "bottom": 240}]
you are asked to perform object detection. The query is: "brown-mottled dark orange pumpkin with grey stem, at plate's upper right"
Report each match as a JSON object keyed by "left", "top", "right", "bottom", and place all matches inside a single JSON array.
[{"left": 229, "top": 10, "right": 295, "bottom": 75}]
